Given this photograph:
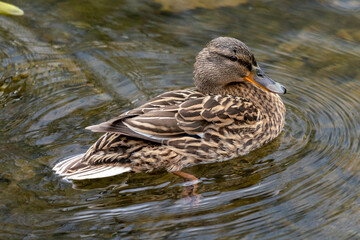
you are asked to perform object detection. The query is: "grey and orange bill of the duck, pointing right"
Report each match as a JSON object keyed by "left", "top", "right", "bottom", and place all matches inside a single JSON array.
[{"left": 244, "top": 67, "right": 286, "bottom": 94}]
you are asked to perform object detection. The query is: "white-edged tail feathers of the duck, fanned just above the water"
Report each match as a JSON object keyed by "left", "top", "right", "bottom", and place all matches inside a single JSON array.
[{"left": 53, "top": 154, "right": 131, "bottom": 180}]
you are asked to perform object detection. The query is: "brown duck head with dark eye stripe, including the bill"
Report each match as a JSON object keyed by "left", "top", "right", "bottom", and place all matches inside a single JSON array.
[{"left": 194, "top": 37, "right": 286, "bottom": 94}]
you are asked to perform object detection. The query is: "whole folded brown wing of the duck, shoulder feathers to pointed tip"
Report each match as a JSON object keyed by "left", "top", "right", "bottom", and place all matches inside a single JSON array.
[{"left": 87, "top": 90, "right": 259, "bottom": 143}]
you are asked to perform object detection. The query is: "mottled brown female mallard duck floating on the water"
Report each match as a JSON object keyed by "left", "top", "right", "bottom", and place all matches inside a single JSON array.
[{"left": 54, "top": 37, "right": 286, "bottom": 180}]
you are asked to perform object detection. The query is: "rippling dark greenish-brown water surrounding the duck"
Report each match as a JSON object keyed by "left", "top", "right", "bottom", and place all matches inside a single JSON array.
[{"left": 0, "top": 0, "right": 360, "bottom": 239}]
